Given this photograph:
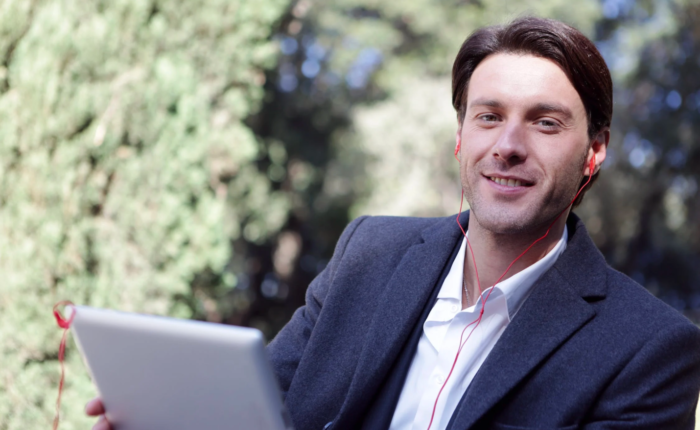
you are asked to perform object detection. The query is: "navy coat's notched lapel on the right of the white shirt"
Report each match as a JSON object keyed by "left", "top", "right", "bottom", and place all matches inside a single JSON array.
[{"left": 448, "top": 215, "right": 606, "bottom": 429}]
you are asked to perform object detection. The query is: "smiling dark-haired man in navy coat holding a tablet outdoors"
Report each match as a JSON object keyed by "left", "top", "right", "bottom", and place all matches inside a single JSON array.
[{"left": 89, "top": 18, "right": 700, "bottom": 430}]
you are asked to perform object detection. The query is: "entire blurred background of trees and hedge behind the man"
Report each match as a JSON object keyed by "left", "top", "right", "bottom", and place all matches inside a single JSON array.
[{"left": 0, "top": 0, "right": 700, "bottom": 430}]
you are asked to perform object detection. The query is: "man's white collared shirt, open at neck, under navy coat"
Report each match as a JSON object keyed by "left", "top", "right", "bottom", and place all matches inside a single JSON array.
[{"left": 390, "top": 227, "right": 568, "bottom": 430}]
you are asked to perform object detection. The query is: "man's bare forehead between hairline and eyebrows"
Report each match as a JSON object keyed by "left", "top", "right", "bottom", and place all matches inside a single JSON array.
[{"left": 467, "top": 54, "right": 586, "bottom": 118}]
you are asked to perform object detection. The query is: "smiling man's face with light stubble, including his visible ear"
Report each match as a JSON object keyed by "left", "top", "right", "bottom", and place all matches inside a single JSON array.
[{"left": 457, "top": 54, "right": 609, "bottom": 234}]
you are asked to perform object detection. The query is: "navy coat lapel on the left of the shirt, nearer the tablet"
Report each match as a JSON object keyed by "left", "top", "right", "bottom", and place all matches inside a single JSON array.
[{"left": 335, "top": 213, "right": 468, "bottom": 428}]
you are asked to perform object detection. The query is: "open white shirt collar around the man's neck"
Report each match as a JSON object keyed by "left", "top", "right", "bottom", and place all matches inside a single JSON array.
[{"left": 437, "top": 226, "right": 569, "bottom": 320}]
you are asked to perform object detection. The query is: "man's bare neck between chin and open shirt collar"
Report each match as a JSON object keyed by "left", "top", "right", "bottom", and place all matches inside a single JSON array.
[{"left": 462, "top": 211, "right": 569, "bottom": 306}]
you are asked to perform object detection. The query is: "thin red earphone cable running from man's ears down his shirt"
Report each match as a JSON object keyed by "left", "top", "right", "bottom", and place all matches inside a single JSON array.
[{"left": 426, "top": 156, "right": 595, "bottom": 430}]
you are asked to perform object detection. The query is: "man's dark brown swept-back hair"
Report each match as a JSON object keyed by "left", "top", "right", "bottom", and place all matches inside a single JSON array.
[{"left": 452, "top": 17, "right": 613, "bottom": 206}]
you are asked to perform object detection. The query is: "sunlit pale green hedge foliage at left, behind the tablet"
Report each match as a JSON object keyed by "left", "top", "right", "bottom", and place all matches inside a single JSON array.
[{"left": 0, "top": 0, "right": 287, "bottom": 429}]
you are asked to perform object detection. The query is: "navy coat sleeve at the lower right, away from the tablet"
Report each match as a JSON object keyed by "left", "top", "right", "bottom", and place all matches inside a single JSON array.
[{"left": 584, "top": 323, "right": 700, "bottom": 430}]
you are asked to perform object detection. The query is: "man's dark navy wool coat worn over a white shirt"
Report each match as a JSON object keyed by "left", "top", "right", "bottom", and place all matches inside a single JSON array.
[{"left": 268, "top": 213, "right": 700, "bottom": 430}]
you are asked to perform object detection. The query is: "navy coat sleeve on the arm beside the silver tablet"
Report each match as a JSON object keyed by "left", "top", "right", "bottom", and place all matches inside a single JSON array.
[{"left": 267, "top": 217, "right": 367, "bottom": 397}]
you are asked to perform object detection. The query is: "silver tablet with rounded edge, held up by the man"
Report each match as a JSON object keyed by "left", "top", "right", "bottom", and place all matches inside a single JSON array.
[{"left": 72, "top": 306, "right": 292, "bottom": 430}]
